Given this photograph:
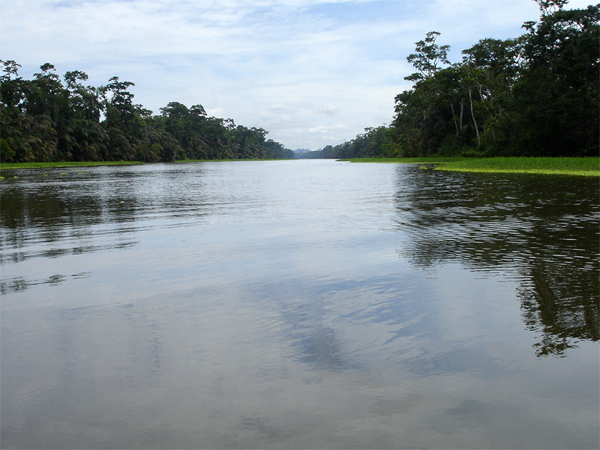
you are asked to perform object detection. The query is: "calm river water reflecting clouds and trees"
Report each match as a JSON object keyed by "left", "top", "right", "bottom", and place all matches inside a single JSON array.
[{"left": 0, "top": 161, "right": 600, "bottom": 449}]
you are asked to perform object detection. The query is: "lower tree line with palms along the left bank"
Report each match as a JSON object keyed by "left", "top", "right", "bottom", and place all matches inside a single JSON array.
[{"left": 0, "top": 60, "right": 294, "bottom": 162}]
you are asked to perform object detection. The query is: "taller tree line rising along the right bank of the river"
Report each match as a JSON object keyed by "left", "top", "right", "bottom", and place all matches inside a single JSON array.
[{"left": 300, "top": 0, "right": 600, "bottom": 158}]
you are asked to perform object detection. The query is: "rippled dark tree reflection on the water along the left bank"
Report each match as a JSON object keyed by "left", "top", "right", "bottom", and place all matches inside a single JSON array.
[{"left": 0, "top": 166, "right": 211, "bottom": 295}]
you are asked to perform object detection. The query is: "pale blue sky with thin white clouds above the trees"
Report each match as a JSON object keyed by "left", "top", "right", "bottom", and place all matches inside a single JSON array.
[{"left": 0, "top": 0, "right": 593, "bottom": 150}]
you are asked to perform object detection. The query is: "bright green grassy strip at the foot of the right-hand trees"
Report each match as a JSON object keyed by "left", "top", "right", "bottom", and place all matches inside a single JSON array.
[{"left": 343, "top": 157, "right": 600, "bottom": 177}]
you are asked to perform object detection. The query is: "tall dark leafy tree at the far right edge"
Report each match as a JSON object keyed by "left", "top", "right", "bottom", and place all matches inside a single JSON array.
[{"left": 514, "top": 2, "right": 600, "bottom": 155}]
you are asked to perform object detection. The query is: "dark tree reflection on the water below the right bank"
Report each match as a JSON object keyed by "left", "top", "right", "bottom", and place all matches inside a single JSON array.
[{"left": 396, "top": 167, "right": 600, "bottom": 356}]
